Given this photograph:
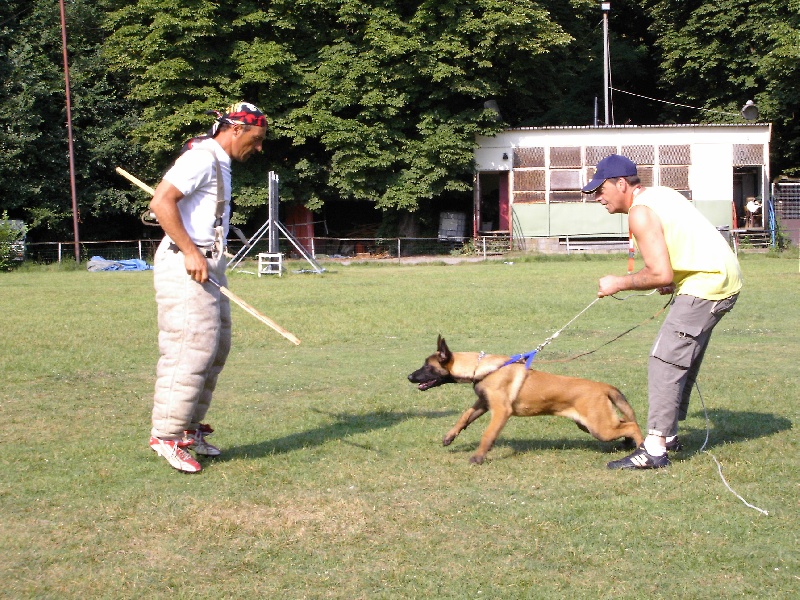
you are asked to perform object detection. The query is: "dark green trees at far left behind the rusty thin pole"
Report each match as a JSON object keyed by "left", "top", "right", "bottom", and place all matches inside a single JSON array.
[{"left": 0, "top": 0, "right": 148, "bottom": 240}]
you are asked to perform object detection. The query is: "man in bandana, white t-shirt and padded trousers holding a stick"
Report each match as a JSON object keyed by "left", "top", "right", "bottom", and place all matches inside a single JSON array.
[{"left": 145, "top": 102, "right": 267, "bottom": 473}]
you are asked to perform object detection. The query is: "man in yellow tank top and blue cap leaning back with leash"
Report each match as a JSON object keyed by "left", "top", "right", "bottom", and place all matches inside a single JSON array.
[{"left": 583, "top": 154, "right": 742, "bottom": 469}]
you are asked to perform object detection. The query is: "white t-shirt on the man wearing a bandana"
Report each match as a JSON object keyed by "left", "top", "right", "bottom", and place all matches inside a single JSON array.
[{"left": 164, "top": 139, "right": 231, "bottom": 247}]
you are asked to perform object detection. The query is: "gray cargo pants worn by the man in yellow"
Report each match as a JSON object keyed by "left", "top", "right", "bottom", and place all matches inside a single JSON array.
[{"left": 647, "top": 294, "right": 738, "bottom": 437}]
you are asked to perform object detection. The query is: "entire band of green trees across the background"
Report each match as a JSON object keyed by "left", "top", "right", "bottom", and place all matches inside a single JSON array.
[{"left": 0, "top": 0, "right": 800, "bottom": 241}]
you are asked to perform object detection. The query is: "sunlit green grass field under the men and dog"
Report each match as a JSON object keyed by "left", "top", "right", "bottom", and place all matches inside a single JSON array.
[{"left": 0, "top": 254, "right": 800, "bottom": 600}]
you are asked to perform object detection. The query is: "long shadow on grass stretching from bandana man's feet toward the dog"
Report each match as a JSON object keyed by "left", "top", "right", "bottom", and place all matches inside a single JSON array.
[{"left": 214, "top": 409, "right": 457, "bottom": 462}]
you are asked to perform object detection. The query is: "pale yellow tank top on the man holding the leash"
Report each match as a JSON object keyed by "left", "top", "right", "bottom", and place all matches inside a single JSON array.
[{"left": 631, "top": 186, "right": 742, "bottom": 300}]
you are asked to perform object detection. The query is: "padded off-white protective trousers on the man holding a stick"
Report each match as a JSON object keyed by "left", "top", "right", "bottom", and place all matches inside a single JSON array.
[{"left": 151, "top": 238, "right": 231, "bottom": 439}]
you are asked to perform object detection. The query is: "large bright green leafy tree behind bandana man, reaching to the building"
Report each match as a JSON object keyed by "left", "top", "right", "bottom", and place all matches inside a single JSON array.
[{"left": 107, "top": 0, "right": 570, "bottom": 218}]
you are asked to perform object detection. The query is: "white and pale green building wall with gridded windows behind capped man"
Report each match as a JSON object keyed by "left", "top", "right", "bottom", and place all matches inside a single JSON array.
[{"left": 475, "top": 124, "right": 771, "bottom": 237}]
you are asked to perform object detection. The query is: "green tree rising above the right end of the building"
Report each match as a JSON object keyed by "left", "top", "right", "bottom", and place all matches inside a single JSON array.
[{"left": 649, "top": 0, "right": 800, "bottom": 173}]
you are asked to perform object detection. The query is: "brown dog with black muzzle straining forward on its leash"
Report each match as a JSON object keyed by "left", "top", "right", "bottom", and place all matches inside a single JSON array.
[{"left": 408, "top": 336, "right": 643, "bottom": 464}]
